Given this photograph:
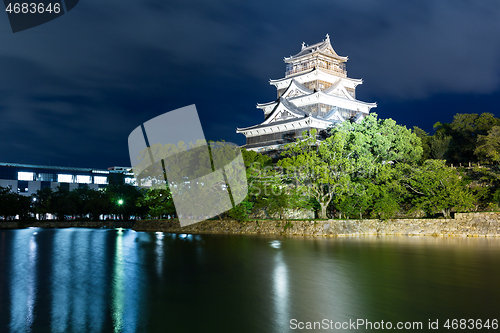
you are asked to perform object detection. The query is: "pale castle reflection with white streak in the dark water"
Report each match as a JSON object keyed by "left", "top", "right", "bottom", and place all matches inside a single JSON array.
[{"left": 268, "top": 238, "right": 366, "bottom": 331}]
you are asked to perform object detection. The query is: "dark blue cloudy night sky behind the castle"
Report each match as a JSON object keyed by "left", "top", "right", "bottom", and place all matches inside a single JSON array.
[{"left": 0, "top": 0, "right": 500, "bottom": 168}]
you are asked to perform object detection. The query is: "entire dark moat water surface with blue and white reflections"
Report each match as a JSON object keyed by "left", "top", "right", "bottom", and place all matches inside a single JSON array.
[{"left": 0, "top": 228, "right": 500, "bottom": 333}]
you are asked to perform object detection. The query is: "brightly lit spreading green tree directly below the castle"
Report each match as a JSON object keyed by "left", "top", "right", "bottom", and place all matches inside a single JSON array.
[{"left": 278, "top": 114, "right": 423, "bottom": 218}]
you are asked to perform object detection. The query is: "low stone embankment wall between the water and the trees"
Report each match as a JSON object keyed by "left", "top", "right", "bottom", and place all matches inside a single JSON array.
[{"left": 133, "top": 213, "right": 500, "bottom": 237}]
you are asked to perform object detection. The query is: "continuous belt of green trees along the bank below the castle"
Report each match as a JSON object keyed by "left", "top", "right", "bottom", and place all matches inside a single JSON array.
[{"left": 0, "top": 113, "right": 500, "bottom": 220}]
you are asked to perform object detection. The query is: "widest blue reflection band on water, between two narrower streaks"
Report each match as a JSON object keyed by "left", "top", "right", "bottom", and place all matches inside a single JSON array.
[{"left": 51, "top": 229, "right": 106, "bottom": 332}]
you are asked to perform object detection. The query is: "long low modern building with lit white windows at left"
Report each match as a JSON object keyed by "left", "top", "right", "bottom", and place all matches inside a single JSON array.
[{"left": 0, "top": 163, "right": 134, "bottom": 196}]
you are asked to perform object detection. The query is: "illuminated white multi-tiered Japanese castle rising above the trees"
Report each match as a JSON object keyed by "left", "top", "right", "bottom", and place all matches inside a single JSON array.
[{"left": 236, "top": 35, "right": 377, "bottom": 152}]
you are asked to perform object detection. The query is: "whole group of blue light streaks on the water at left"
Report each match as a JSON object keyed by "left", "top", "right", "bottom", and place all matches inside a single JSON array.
[{"left": 5, "top": 229, "right": 147, "bottom": 333}]
